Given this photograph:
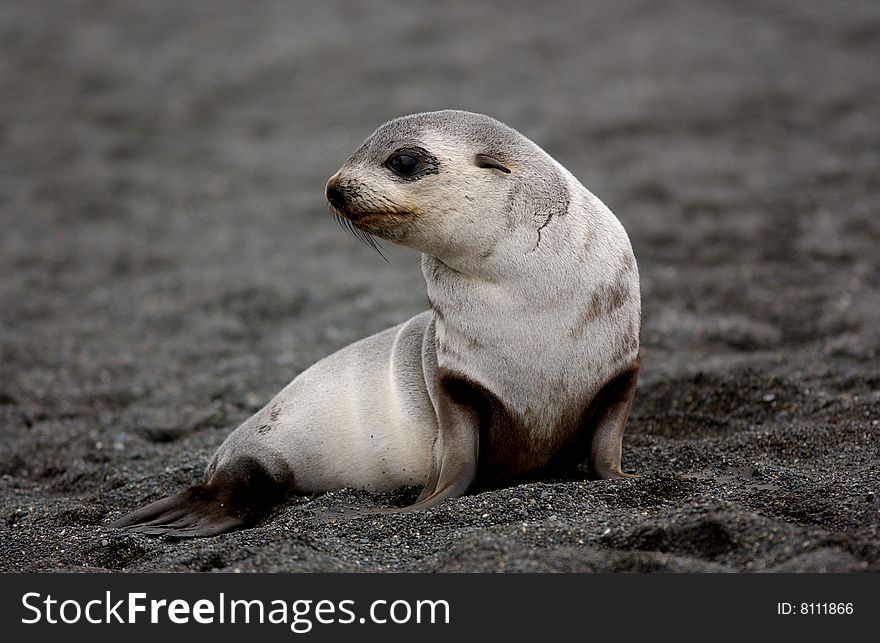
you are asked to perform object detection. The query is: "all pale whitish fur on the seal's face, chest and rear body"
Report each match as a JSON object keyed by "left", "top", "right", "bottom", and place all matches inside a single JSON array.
[{"left": 209, "top": 113, "right": 640, "bottom": 492}]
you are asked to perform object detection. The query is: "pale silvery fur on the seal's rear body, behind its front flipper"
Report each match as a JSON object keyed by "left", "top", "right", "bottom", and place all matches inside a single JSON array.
[{"left": 209, "top": 312, "right": 437, "bottom": 492}]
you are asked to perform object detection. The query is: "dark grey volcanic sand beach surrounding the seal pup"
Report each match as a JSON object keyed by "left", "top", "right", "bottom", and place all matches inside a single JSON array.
[{"left": 0, "top": 0, "right": 880, "bottom": 571}]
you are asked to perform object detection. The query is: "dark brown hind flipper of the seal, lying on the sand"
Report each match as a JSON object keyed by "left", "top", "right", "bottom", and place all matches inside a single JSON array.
[{"left": 110, "top": 457, "right": 292, "bottom": 538}]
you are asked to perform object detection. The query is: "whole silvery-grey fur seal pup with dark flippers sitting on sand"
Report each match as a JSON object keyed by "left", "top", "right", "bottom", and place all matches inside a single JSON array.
[{"left": 112, "top": 110, "right": 641, "bottom": 537}]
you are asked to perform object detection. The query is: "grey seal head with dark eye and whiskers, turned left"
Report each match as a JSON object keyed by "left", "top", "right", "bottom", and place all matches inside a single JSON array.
[{"left": 326, "top": 110, "right": 568, "bottom": 270}]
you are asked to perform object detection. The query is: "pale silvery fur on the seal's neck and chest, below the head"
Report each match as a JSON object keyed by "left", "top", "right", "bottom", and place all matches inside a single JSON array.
[{"left": 422, "top": 173, "right": 640, "bottom": 437}]
